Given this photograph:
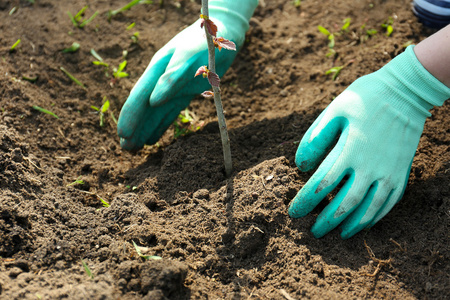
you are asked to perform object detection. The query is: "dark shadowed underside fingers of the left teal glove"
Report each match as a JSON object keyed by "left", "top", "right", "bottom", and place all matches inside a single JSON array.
[{"left": 120, "top": 97, "right": 191, "bottom": 151}]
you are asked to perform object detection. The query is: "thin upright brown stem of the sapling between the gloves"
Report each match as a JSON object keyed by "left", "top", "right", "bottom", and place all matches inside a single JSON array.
[{"left": 202, "top": 0, "right": 233, "bottom": 177}]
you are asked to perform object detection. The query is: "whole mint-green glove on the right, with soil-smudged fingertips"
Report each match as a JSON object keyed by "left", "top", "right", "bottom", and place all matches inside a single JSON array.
[{"left": 289, "top": 46, "right": 450, "bottom": 238}]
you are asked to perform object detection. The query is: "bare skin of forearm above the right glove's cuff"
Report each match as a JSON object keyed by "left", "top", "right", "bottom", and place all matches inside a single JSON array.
[{"left": 414, "top": 25, "right": 450, "bottom": 87}]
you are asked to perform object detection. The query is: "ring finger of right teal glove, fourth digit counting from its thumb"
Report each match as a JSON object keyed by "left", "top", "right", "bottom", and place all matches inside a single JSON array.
[{"left": 341, "top": 181, "right": 393, "bottom": 239}]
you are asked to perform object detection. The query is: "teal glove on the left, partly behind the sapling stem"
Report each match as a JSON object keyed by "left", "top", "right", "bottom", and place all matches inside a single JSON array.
[{"left": 117, "top": 0, "right": 258, "bottom": 150}]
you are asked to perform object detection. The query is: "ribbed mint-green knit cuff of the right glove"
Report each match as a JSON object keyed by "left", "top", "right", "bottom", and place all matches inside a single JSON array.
[{"left": 375, "top": 45, "right": 450, "bottom": 117}]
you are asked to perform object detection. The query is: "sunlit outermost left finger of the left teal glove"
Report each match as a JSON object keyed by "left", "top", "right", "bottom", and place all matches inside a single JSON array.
[{"left": 117, "top": 54, "right": 172, "bottom": 139}]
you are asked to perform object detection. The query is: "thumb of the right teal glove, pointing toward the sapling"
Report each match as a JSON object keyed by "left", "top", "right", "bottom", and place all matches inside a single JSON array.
[{"left": 295, "top": 108, "right": 348, "bottom": 172}]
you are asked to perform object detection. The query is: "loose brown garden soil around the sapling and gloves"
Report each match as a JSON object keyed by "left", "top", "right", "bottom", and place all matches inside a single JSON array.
[{"left": 0, "top": 0, "right": 450, "bottom": 299}]
